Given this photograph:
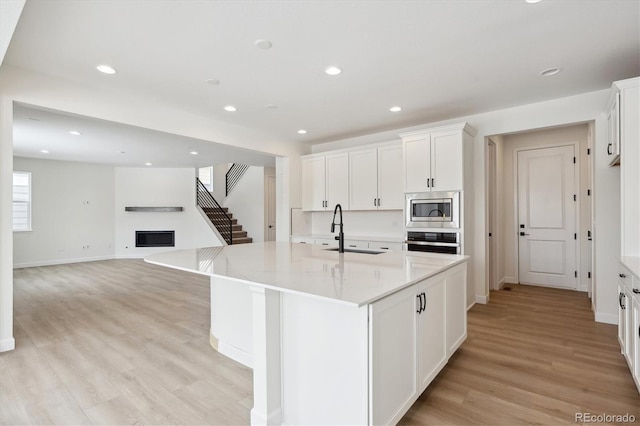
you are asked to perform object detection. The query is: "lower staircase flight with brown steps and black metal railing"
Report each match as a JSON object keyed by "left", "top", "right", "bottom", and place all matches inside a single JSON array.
[{"left": 196, "top": 178, "right": 253, "bottom": 245}]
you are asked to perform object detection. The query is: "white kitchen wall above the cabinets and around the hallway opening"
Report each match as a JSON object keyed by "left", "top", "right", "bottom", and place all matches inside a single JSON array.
[{"left": 312, "top": 89, "right": 620, "bottom": 323}]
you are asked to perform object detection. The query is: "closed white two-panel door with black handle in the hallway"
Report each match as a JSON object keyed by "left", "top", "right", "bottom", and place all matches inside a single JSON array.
[{"left": 518, "top": 145, "right": 578, "bottom": 289}]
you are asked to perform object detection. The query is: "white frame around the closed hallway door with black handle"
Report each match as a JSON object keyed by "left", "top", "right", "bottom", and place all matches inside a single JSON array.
[{"left": 511, "top": 141, "right": 582, "bottom": 291}]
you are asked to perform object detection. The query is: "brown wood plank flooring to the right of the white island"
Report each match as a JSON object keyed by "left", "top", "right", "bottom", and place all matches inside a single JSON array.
[{"left": 401, "top": 285, "right": 640, "bottom": 425}]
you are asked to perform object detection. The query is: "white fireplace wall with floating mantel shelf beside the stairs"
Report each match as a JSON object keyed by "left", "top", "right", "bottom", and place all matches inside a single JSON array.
[{"left": 114, "top": 167, "right": 220, "bottom": 258}]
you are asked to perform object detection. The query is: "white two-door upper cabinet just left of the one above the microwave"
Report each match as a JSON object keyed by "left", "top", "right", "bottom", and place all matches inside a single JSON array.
[{"left": 349, "top": 144, "right": 404, "bottom": 210}]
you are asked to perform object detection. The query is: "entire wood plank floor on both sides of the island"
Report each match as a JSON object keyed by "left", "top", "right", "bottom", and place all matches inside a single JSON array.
[{"left": 0, "top": 260, "right": 640, "bottom": 425}]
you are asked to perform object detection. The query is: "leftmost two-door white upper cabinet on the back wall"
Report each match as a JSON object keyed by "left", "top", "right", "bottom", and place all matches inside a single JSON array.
[{"left": 302, "top": 153, "right": 349, "bottom": 211}]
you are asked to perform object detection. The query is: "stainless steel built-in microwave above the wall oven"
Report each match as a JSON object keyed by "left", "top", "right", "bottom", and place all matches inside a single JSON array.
[{"left": 405, "top": 191, "right": 460, "bottom": 228}]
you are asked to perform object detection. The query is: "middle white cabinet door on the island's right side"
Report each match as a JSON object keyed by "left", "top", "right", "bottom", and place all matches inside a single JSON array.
[{"left": 418, "top": 275, "right": 447, "bottom": 393}]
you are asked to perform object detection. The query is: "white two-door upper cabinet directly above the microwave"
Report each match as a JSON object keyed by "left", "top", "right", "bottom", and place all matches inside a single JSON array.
[{"left": 402, "top": 128, "right": 464, "bottom": 192}]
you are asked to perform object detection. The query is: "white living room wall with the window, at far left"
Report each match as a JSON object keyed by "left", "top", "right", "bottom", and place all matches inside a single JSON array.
[{"left": 13, "top": 157, "right": 114, "bottom": 268}]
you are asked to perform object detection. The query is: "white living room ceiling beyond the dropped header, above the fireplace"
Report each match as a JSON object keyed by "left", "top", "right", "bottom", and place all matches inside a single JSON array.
[{"left": 13, "top": 104, "right": 275, "bottom": 167}]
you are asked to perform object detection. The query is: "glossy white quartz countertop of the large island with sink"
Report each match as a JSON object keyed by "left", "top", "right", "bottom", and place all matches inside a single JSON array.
[{"left": 145, "top": 242, "right": 468, "bottom": 306}]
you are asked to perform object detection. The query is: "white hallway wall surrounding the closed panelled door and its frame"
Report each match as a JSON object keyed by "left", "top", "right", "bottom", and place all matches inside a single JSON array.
[{"left": 497, "top": 124, "right": 591, "bottom": 291}]
